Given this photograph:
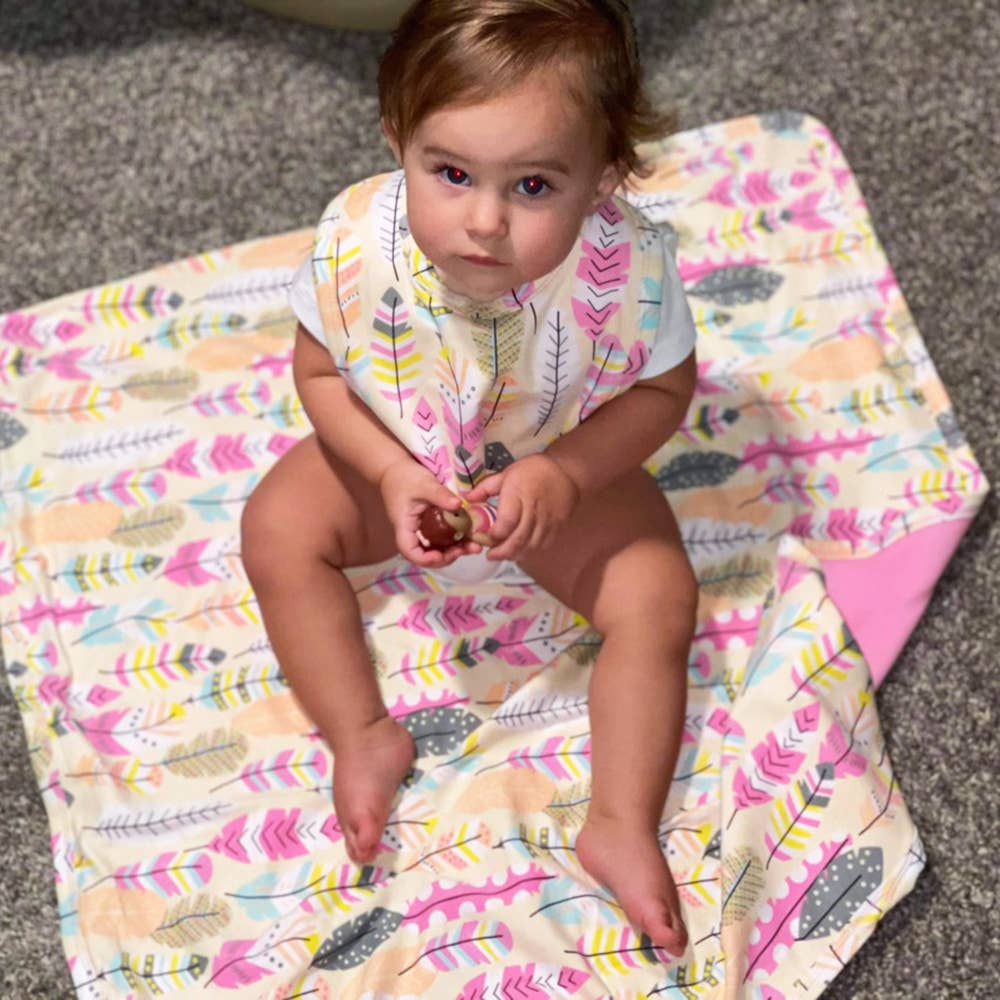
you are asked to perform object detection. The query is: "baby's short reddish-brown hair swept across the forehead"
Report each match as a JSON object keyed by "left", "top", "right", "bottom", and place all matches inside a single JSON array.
[{"left": 378, "top": 0, "right": 673, "bottom": 176}]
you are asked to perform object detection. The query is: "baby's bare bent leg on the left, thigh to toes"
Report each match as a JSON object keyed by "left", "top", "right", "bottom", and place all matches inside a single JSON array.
[{"left": 242, "top": 435, "right": 413, "bottom": 862}]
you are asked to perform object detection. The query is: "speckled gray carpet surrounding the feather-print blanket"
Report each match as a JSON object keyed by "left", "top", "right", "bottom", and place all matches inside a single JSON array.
[{"left": 0, "top": 0, "right": 1000, "bottom": 1000}]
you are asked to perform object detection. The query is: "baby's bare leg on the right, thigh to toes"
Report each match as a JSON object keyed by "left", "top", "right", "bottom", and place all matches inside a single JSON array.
[{"left": 519, "top": 470, "right": 697, "bottom": 954}]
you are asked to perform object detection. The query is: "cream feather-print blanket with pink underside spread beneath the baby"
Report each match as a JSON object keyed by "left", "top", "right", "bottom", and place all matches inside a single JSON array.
[{"left": 0, "top": 113, "right": 987, "bottom": 1000}]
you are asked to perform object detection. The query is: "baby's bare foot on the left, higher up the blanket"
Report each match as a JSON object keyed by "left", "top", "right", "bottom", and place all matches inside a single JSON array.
[{"left": 333, "top": 716, "right": 414, "bottom": 864}]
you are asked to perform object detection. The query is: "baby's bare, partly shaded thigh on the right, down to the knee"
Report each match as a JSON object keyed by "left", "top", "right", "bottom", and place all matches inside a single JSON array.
[{"left": 518, "top": 469, "right": 697, "bottom": 628}]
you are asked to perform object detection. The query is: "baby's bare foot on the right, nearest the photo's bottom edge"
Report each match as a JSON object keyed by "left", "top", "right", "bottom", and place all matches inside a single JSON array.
[{"left": 576, "top": 815, "right": 687, "bottom": 955}]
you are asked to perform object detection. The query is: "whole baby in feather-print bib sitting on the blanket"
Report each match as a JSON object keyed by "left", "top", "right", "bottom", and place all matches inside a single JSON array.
[{"left": 242, "top": 0, "right": 697, "bottom": 953}]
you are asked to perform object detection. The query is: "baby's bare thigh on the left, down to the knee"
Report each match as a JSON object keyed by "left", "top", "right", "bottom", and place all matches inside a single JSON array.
[{"left": 243, "top": 434, "right": 397, "bottom": 567}]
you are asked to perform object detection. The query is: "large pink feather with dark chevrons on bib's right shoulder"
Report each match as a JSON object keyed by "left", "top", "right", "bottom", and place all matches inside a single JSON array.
[{"left": 572, "top": 199, "right": 632, "bottom": 341}]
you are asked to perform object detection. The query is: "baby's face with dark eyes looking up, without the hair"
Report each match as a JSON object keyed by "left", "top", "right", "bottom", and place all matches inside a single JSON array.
[{"left": 394, "top": 73, "right": 620, "bottom": 301}]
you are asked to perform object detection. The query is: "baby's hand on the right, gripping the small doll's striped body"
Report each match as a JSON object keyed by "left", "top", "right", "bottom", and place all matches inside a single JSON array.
[{"left": 465, "top": 453, "right": 580, "bottom": 559}]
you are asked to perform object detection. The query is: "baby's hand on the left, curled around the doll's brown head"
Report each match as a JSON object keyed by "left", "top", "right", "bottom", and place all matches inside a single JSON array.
[{"left": 378, "top": 459, "right": 481, "bottom": 568}]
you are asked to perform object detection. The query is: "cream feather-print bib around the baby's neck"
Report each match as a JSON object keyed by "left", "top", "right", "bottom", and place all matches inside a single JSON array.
[{"left": 313, "top": 171, "right": 665, "bottom": 494}]
